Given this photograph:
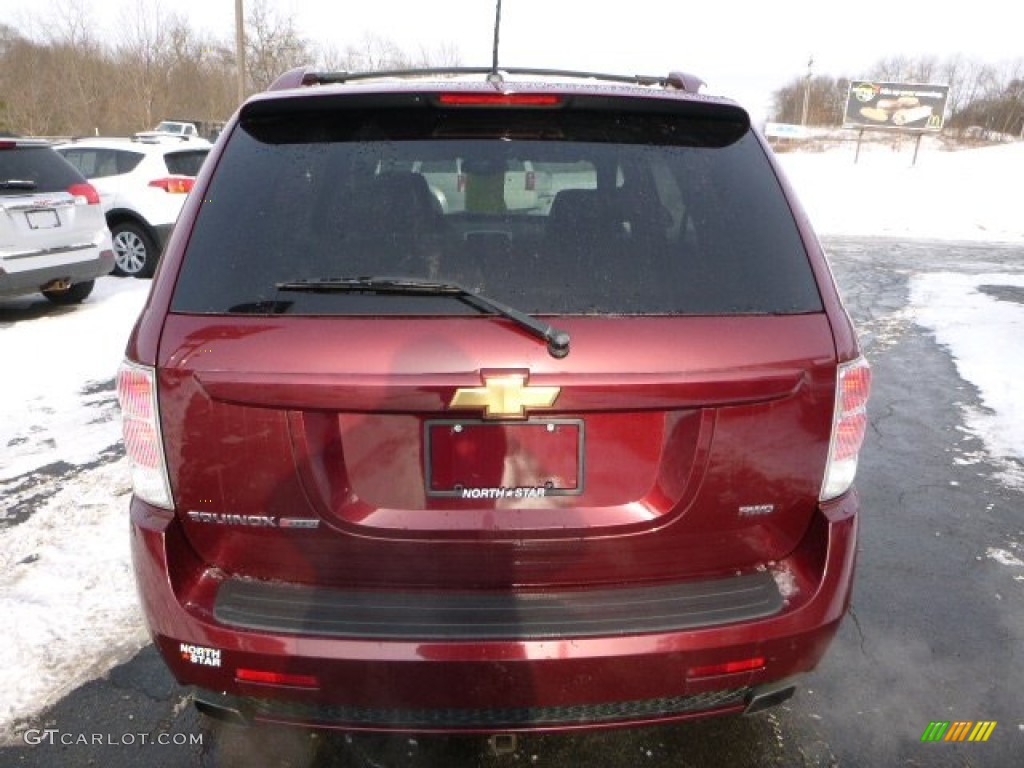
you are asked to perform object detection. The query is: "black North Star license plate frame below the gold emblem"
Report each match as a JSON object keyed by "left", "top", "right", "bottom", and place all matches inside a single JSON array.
[{"left": 423, "top": 419, "right": 585, "bottom": 501}]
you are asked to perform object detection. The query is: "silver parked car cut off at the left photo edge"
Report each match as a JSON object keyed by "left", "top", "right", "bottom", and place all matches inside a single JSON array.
[{"left": 0, "top": 138, "right": 114, "bottom": 304}]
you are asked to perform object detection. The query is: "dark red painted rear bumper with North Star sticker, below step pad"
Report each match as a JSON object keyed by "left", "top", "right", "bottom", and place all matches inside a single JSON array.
[{"left": 132, "top": 494, "right": 857, "bottom": 732}]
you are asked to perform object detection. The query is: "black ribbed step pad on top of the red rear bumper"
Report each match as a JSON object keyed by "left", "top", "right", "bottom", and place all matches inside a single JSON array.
[{"left": 214, "top": 571, "right": 783, "bottom": 641}]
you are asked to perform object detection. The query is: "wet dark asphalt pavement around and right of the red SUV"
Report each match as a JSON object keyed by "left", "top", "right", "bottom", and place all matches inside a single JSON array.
[{"left": 0, "top": 239, "right": 1024, "bottom": 768}]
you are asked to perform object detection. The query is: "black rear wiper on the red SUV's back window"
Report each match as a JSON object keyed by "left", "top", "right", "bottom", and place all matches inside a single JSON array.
[{"left": 276, "top": 278, "right": 569, "bottom": 358}]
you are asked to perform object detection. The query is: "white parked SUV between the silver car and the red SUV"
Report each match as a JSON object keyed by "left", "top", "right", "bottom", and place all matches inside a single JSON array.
[{"left": 55, "top": 137, "right": 212, "bottom": 278}]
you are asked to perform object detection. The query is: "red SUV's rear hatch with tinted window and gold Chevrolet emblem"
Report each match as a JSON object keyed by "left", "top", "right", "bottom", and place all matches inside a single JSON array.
[{"left": 149, "top": 82, "right": 837, "bottom": 589}]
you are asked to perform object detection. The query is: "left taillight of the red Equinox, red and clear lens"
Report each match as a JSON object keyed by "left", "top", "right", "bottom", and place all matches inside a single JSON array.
[{"left": 118, "top": 360, "right": 174, "bottom": 509}]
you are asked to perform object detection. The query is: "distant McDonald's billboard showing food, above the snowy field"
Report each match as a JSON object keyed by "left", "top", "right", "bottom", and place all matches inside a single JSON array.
[{"left": 843, "top": 80, "right": 949, "bottom": 131}]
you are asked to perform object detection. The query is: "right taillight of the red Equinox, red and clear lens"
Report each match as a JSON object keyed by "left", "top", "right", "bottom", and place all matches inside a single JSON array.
[{"left": 820, "top": 357, "right": 871, "bottom": 501}]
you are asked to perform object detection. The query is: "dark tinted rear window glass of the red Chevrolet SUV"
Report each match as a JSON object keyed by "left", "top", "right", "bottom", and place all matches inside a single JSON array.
[{"left": 172, "top": 99, "right": 821, "bottom": 314}]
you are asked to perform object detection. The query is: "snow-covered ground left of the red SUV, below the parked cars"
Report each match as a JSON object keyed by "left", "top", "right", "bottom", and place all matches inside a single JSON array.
[{"left": 0, "top": 278, "right": 148, "bottom": 743}]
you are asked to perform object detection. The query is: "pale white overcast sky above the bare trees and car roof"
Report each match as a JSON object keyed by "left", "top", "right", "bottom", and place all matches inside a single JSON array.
[{"left": 8, "top": 0, "right": 1024, "bottom": 119}]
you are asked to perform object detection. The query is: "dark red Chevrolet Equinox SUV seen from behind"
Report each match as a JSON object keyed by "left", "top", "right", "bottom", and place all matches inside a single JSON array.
[{"left": 118, "top": 70, "right": 869, "bottom": 732}]
